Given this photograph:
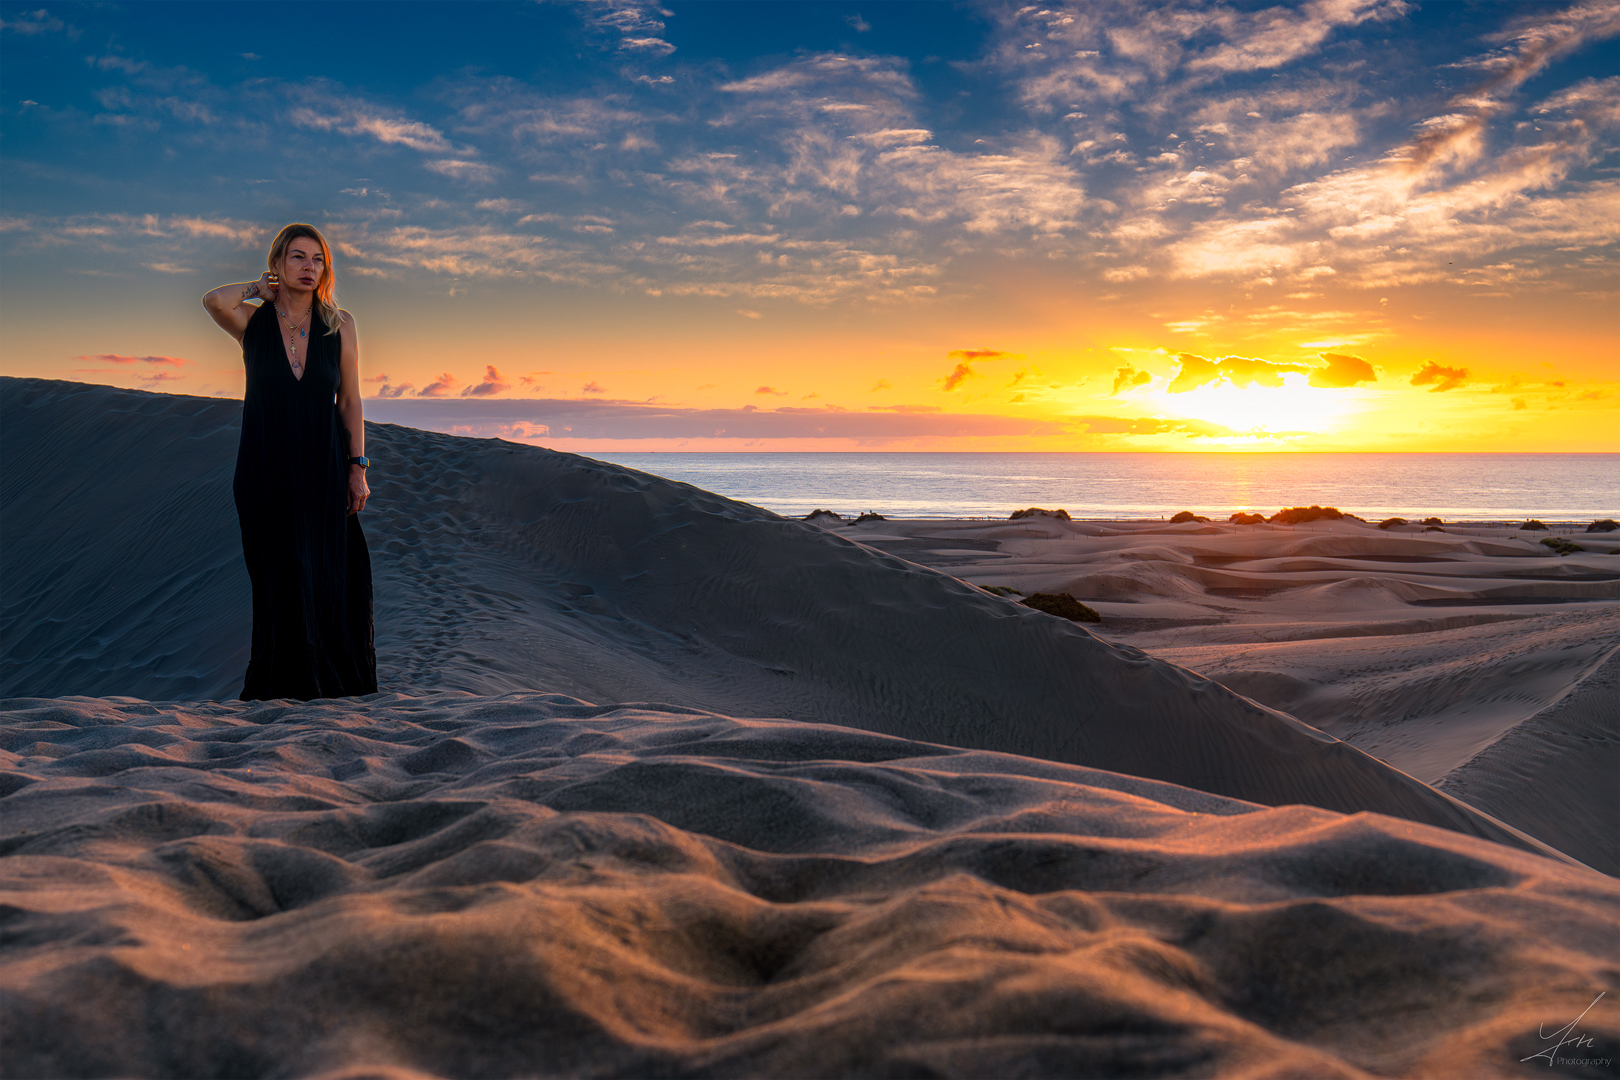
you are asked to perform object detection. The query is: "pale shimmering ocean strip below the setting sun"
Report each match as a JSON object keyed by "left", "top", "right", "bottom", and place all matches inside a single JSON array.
[{"left": 590, "top": 453, "right": 1620, "bottom": 521}]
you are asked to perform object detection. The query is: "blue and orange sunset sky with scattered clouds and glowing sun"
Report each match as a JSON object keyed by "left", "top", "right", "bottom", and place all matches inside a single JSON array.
[{"left": 0, "top": 0, "right": 1620, "bottom": 452}]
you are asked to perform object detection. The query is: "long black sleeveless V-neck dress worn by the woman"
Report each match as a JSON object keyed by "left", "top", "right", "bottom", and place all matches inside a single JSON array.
[{"left": 233, "top": 303, "right": 377, "bottom": 701}]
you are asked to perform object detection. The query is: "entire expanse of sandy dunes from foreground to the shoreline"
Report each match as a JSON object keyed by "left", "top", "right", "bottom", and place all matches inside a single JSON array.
[{"left": 0, "top": 379, "right": 1620, "bottom": 1078}]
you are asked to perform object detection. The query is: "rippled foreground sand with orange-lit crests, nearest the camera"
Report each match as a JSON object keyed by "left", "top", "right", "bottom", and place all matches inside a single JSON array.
[{"left": 0, "top": 691, "right": 1620, "bottom": 1080}]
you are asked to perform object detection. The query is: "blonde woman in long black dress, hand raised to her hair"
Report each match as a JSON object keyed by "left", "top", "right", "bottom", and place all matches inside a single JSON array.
[{"left": 203, "top": 225, "right": 377, "bottom": 701}]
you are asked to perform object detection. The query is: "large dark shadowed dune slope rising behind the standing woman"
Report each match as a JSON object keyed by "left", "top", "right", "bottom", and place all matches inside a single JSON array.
[{"left": 0, "top": 379, "right": 1550, "bottom": 852}]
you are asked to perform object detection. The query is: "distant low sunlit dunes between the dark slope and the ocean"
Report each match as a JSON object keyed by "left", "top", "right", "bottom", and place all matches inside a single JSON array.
[{"left": 839, "top": 518, "right": 1620, "bottom": 874}]
